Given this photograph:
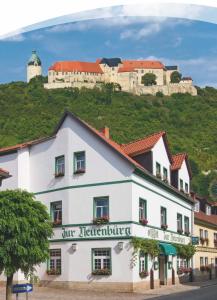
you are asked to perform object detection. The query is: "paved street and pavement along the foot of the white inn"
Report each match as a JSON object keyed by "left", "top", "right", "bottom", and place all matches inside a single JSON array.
[{"left": 0, "top": 282, "right": 217, "bottom": 300}]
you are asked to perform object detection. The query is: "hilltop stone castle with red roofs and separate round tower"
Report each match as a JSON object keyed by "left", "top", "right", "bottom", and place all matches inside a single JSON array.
[{"left": 27, "top": 52, "right": 197, "bottom": 96}]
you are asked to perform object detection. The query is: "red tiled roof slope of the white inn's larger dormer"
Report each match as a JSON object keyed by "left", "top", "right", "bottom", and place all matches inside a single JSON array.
[{"left": 121, "top": 131, "right": 165, "bottom": 156}]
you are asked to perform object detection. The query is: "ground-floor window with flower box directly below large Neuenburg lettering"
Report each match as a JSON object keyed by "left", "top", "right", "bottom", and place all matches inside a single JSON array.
[{"left": 92, "top": 248, "right": 111, "bottom": 275}]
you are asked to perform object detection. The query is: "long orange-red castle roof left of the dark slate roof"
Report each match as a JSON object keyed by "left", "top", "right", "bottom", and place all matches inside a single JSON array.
[{"left": 49, "top": 61, "right": 103, "bottom": 74}]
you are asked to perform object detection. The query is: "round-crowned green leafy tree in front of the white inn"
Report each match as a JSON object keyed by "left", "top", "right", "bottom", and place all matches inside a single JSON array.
[{"left": 0, "top": 190, "right": 52, "bottom": 300}]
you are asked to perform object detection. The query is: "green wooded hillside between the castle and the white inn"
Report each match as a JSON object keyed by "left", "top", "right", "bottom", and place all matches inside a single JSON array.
[{"left": 0, "top": 78, "right": 217, "bottom": 195}]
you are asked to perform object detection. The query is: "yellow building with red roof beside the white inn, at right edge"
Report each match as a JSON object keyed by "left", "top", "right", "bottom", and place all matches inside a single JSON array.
[{"left": 194, "top": 196, "right": 217, "bottom": 280}]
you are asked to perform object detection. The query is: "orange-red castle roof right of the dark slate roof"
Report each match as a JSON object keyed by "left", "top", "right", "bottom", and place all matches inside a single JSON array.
[{"left": 118, "top": 60, "right": 165, "bottom": 72}]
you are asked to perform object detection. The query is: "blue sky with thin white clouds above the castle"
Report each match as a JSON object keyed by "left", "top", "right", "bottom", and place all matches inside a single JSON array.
[{"left": 0, "top": 17, "right": 217, "bottom": 87}]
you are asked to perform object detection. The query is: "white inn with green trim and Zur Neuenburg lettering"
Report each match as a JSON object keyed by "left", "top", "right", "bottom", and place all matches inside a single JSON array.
[{"left": 0, "top": 112, "right": 193, "bottom": 291}]
